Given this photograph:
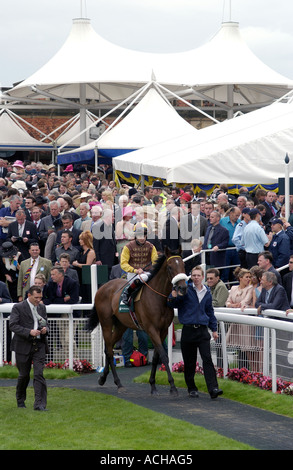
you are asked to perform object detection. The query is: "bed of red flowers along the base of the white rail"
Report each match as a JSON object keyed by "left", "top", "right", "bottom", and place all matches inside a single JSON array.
[{"left": 160, "top": 361, "right": 293, "bottom": 395}]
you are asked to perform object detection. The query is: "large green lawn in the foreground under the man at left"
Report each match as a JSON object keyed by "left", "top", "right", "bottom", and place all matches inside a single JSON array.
[{"left": 0, "top": 387, "right": 252, "bottom": 451}]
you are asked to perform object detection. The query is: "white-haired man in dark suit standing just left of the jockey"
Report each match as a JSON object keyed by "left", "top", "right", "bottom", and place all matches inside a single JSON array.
[{"left": 92, "top": 209, "right": 118, "bottom": 276}]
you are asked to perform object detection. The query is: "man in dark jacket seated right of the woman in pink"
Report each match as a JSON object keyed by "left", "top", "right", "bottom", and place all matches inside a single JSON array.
[{"left": 255, "top": 271, "right": 290, "bottom": 314}]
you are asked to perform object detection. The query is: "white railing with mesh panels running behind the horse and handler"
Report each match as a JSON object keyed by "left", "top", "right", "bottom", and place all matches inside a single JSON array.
[{"left": 0, "top": 255, "right": 293, "bottom": 392}]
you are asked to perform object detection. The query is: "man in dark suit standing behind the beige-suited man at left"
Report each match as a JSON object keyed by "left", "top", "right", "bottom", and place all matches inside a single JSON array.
[{"left": 7, "top": 209, "right": 38, "bottom": 259}]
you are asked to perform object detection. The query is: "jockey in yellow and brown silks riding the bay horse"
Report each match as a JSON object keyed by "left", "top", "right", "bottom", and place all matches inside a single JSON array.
[{"left": 120, "top": 223, "right": 158, "bottom": 305}]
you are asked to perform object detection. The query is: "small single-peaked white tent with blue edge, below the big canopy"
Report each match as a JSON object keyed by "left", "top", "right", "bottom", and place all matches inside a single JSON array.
[{"left": 58, "top": 88, "right": 198, "bottom": 164}]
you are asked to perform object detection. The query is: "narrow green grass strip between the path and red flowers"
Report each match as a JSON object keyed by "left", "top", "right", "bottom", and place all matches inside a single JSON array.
[{"left": 135, "top": 371, "right": 293, "bottom": 418}]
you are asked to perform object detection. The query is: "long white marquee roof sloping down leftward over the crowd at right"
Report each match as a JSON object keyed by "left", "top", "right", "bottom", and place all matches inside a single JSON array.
[{"left": 113, "top": 96, "right": 293, "bottom": 184}]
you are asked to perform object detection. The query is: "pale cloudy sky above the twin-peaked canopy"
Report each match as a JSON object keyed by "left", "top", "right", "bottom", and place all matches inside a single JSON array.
[{"left": 0, "top": 0, "right": 293, "bottom": 87}]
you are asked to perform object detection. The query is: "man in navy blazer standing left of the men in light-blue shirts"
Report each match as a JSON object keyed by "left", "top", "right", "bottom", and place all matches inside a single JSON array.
[{"left": 202, "top": 211, "right": 229, "bottom": 267}]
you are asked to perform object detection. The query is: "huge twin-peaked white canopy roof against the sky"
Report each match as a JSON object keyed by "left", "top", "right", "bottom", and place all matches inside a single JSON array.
[{"left": 4, "top": 18, "right": 293, "bottom": 110}]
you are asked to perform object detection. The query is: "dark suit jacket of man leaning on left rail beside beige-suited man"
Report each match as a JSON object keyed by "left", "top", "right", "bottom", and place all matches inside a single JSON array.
[{"left": 43, "top": 275, "right": 79, "bottom": 305}]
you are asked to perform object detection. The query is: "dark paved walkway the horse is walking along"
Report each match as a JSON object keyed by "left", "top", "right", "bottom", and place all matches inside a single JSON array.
[{"left": 0, "top": 366, "right": 293, "bottom": 450}]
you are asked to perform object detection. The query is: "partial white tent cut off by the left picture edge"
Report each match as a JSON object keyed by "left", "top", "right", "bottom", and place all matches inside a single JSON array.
[{"left": 0, "top": 109, "right": 53, "bottom": 152}]
